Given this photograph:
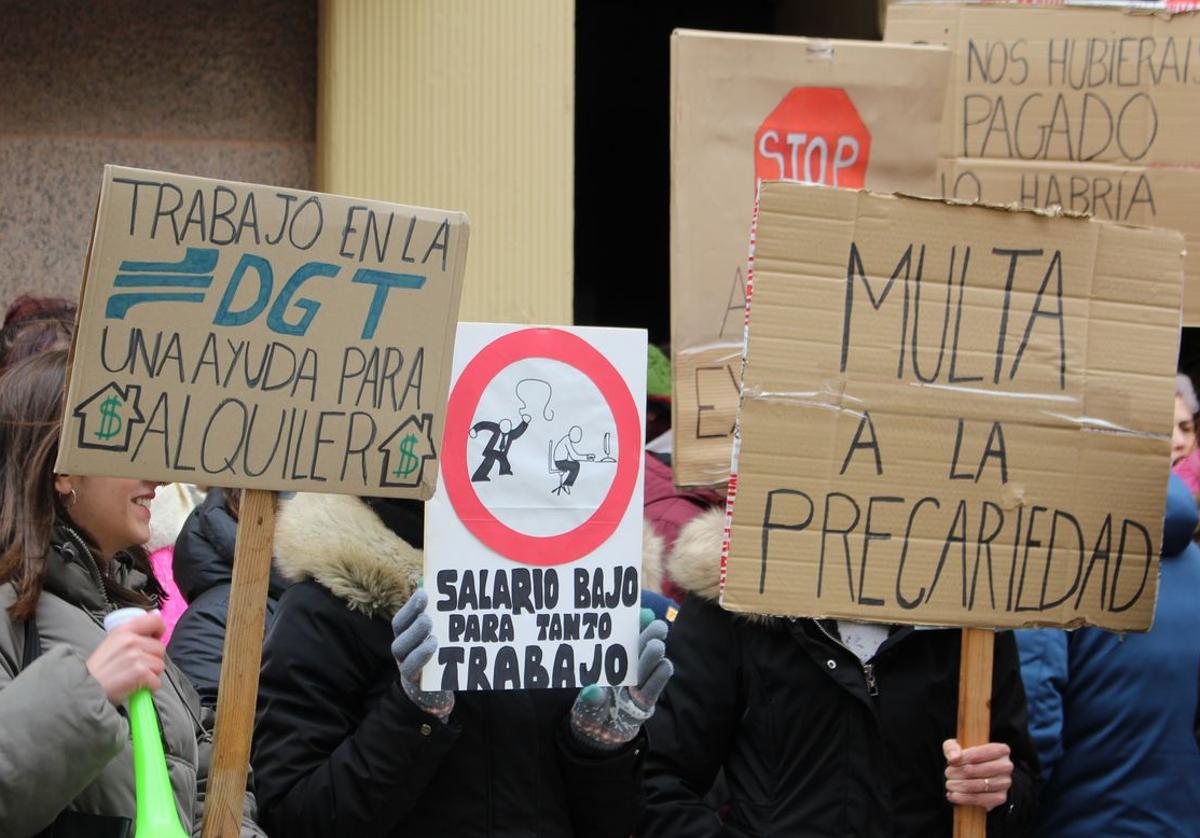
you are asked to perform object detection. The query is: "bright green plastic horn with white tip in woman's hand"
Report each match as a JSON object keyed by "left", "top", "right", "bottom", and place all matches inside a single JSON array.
[{"left": 104, "top": 609, "right": 190, "bottom": 838}]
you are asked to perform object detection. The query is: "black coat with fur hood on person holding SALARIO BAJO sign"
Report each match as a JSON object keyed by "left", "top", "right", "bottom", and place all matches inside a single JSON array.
[{"left": 253, "top": 495, "right": 644, "bottom": 838}]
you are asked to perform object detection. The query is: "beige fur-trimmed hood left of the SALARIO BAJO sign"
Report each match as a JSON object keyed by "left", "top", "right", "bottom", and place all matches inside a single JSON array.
[{"left": 275, "top": 492, "right": 425, "bottom": 617}]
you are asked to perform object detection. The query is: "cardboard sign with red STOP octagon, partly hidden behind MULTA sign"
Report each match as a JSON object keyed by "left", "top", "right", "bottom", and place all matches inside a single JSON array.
[{"left": 671, "top": 31, "right": 949, "bottom": 485}]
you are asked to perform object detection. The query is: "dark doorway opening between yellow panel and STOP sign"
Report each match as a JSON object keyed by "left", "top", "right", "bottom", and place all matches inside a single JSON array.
[{"left": 575, "top": 0, "right": 881, "bottom": 343}]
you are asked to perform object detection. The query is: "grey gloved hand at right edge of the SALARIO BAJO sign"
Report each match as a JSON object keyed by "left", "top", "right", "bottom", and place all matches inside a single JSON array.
[{"left": 571, "top": 609, "right": 674, "bottom": 750}]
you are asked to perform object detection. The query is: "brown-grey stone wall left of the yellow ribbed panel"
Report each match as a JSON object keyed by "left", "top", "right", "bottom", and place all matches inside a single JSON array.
[{"left": 0, "top": 0, "right": 317, "bottom": 300}]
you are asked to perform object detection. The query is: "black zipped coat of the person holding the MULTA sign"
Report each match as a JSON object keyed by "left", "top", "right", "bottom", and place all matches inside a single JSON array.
[{"left": 641, "top": 593, "right": 1037, "bottom": 838}]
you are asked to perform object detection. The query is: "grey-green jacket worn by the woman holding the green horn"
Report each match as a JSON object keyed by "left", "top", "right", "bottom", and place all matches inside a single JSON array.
[{"left": 0, "top": 528, "right": 264, "bottom": 838}]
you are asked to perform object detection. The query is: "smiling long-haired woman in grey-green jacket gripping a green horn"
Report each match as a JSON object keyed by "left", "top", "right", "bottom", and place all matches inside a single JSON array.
[{"left": 0, "top": 351, "right": 267, "bottom": 836}]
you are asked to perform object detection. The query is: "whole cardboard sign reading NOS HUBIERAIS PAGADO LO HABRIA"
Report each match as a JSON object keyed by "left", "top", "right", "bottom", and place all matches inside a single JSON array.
[{"left": 884, "top": 4, "right": 1200, "bottom": 324}]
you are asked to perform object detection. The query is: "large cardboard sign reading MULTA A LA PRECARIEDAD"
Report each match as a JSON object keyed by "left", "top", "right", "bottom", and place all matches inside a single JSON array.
[{"left": 722, "top": 184, "right": 1183, "bottom": 630}]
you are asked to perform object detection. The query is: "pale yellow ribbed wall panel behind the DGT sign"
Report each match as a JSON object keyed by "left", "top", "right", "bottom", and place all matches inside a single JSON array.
[{"left": 316, "top": 0, "right": 575, "bottom": 323}]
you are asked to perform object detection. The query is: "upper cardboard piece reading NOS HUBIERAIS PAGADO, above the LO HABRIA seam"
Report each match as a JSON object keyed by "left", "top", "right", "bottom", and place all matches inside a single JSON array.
[{"left": 886, "top": 2, "right": 1200, "bottom": 166}]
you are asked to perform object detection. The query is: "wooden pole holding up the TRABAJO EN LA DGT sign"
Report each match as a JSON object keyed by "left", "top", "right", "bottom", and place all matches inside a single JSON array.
[{"left": 203, "top": 489, "right": 275, "bottom": 838}]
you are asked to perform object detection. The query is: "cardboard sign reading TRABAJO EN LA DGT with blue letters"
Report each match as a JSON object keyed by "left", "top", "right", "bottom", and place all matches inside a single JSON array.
[{"left": 55, "top": 166, "right": 468, "bottom": 498}]
